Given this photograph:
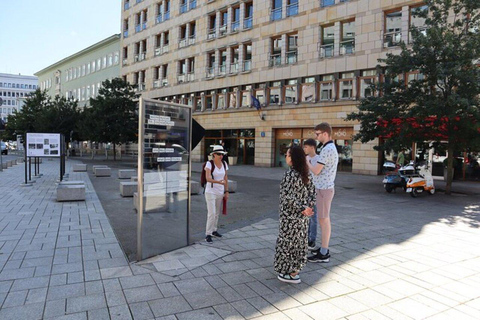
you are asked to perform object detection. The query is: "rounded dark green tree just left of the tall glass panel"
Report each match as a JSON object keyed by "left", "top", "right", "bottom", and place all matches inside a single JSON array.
[{"left": 87, "top": 78, "right": 139, "bottom": 160}]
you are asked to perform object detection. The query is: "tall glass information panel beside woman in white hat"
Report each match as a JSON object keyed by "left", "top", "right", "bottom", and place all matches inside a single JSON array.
[{"left": 137, "top": 98, "right": 192, "bottom": 260}]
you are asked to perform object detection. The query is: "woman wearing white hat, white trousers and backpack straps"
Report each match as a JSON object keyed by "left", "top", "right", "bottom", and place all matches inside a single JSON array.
[{"left": 204, "top": 146, "right": 228, "bottom": 243}]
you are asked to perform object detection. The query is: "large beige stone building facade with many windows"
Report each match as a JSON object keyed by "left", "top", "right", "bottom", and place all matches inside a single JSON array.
[{"left": 121, "top": 0, "right": 423, "bottom": 174}]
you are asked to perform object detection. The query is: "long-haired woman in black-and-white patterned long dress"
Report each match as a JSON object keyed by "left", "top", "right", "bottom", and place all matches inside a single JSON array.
[{"left": 274, "top": 146, "right": 315, "bottom": 283}]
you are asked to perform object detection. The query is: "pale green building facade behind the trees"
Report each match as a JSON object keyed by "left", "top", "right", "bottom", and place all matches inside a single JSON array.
[{"left": 35, "top": 34, "right": 120, "bottom": 107}]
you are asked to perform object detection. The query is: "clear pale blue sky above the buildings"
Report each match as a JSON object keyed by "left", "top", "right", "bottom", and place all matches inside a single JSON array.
[{"left": 0, "top": 0, "right": 122, "bottom": 75}]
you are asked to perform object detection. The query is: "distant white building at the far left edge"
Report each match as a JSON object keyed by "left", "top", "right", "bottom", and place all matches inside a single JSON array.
[{"left": 0, "top": 73, "right": 38, "bottom": 121}]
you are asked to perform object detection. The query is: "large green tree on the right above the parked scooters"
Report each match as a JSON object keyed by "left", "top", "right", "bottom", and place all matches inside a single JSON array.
[{"left": 346, "top": 0, "right": 480, "bottom": 194}]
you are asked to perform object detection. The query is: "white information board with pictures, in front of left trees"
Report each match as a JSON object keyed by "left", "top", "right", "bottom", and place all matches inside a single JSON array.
[{"left": 26, "top": 133, "right": 61, "bottom": 158}]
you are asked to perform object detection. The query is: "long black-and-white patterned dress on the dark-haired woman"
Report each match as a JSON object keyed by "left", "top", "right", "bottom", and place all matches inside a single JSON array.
[{"left": 274, "top": 168, "right": 315, "bottom": 274}]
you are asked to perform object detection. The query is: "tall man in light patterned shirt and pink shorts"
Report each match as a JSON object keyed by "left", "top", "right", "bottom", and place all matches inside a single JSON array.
[{"left": 308, "top": 122, "right": 338, "bottom": 262}]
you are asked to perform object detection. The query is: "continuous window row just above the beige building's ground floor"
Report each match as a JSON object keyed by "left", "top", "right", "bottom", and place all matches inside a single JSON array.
[{"left": 154, "top": 70, "right": 423, "bottom": 112}]
